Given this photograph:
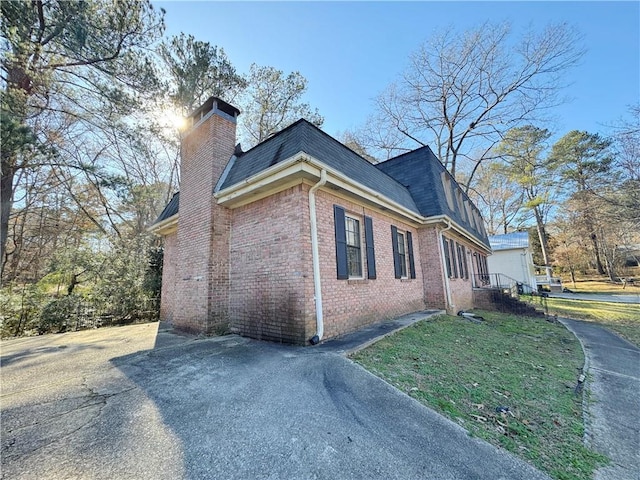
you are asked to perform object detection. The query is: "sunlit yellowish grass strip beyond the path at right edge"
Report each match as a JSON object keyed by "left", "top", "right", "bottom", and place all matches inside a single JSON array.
[{"left": 547, "top": 298, "right": 640, "bottom": 347}]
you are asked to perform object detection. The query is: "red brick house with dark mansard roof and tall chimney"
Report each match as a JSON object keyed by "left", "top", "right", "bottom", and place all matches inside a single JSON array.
[{"left": 151, "top": 97, "right": 490, "bottom": 344}]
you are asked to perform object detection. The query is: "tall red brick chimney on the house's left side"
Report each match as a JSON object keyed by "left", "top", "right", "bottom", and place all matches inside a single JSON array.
[{"left": 172, "top": 97, "right": 240, "bottom": 333}]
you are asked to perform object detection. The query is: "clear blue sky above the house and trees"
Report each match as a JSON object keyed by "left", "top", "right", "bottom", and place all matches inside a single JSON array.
[{"left": 154, "top": 1, "right": 640, "bottom": 140}]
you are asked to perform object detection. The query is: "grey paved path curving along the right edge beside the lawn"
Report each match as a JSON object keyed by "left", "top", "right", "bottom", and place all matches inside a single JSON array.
[{"left": 561, "top": 318, "right": 640, "bottom": 480}]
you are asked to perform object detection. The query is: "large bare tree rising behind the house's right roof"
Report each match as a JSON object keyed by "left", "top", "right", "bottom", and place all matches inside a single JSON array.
[{"left": 364, "top": 22, "right": 584, "bottom": 188}]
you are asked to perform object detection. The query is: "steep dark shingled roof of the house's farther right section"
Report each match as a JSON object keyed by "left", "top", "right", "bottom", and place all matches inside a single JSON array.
[{"left": 375, "top": 147, "right": 489, "bottom": 246}]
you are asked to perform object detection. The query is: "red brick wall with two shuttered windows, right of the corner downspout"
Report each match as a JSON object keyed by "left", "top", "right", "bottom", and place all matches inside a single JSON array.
[{"left": 316, "top": 190, "right": 424, "bottom": 338}]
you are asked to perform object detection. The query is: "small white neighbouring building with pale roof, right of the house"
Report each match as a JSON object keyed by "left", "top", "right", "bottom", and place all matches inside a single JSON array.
[{"left": 487, "top": 232, "right": 538, "bottom": 291}]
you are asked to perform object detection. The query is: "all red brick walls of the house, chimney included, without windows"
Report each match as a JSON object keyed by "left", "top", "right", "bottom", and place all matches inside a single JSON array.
[{"left": 161, "top": 101, "right": 484, "bottom": 344}]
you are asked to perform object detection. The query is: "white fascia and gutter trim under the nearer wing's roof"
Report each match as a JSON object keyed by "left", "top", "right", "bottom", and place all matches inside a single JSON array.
[{"left": 214, "top": 152, "right": 425, "bottom": 223}]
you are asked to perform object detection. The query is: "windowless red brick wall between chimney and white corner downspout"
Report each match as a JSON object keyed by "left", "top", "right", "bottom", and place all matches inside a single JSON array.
[{"left": 230, "top": 185, "right": 315, "bottom": 344}]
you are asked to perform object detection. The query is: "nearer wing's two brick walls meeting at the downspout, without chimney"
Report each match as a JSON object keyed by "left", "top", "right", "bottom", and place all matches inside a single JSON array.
[{"left": 225, "top": 185, "right": 442, "bottom": 344}]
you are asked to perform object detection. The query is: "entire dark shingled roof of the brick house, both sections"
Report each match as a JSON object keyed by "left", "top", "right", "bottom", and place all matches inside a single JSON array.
[{"left": 155, "top": 119, "right": 489, "bottom": 247}]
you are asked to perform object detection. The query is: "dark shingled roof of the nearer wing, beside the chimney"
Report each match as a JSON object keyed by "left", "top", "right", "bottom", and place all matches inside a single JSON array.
[{"left": 220, "top": 119, "right": 419, "bottom": 213}]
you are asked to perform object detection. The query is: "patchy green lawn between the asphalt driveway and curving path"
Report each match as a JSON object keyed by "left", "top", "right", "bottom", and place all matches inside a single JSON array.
[{"left": 353, "top": 312, "right": 606, "bottom": 480}]
